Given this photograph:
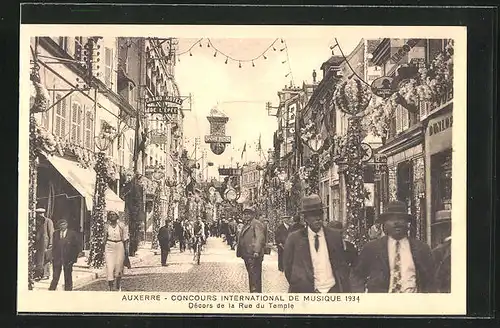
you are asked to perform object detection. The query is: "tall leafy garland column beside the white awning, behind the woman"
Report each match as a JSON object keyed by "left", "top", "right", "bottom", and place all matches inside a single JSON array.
[{"left": 88, "top": 152, "right": 108, "bottom": 269}]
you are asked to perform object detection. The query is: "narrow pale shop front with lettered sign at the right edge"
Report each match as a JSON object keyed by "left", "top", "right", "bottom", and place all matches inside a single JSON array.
[{"left": 425, "top": 104, "right": 453, "bottom": 247}]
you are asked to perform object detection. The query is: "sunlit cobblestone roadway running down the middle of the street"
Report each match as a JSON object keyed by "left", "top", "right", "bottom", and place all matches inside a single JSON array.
[{"left": 77, "top": 237, "right": 288, "bottom": 293}]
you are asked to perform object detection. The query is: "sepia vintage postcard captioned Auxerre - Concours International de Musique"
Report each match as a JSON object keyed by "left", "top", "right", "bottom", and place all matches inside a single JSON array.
[{"left": 17, "top": 25, "right": 467, "bottom": 315}]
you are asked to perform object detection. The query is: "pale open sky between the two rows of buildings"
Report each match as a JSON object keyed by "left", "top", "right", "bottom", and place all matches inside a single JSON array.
[{"left": 175, "top": 33, "right": 361, "bottom": 177}]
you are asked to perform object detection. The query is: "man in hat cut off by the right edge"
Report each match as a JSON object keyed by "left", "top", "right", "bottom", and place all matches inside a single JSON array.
[{"left": 432, "top": 210, "right": 451, "bottom": 293}]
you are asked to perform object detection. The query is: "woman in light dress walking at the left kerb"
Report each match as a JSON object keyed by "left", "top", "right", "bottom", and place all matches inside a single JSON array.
[{"left": 104, "top": 211, "right": 129, "bottom": 291}]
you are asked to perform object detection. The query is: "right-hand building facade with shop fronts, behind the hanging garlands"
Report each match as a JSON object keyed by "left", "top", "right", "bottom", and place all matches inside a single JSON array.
[{"left": 373, "top": 39, "right": 453, "bottom": 246}]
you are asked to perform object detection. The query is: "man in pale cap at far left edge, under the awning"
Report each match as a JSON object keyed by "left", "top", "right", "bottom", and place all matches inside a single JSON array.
[{"left": 35, "top": 208, "right": 54, "bottom": 280}]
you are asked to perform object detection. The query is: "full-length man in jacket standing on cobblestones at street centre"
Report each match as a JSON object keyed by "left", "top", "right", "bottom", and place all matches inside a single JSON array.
[{"left": 236, "top": 206, "right": 266, "bottom": 293}]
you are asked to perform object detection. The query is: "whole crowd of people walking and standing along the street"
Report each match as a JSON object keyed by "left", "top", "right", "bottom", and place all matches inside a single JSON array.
[{"left": 34, "top": 191, "right": 451, "bottom": 293}]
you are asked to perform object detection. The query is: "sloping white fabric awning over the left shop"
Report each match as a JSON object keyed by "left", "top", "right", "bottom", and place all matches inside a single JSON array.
[{"left": 47, "top": 156, "right": 125, "bottom": 212}]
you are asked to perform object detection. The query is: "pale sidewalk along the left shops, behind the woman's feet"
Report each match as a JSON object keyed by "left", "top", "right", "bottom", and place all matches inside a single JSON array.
[{"left": 33, "top": 242, "right": 156, "bottom": 290}]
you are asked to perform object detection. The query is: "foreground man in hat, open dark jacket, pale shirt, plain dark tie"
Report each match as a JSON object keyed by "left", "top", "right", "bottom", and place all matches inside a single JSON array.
[{"left": 283, "top": 194, "right": 350, "bottom": 293}]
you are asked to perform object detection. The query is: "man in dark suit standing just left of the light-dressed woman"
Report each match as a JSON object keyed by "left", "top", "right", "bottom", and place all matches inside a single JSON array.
[{"left": 49, "top": 219, "right": 80, "bottom": 291}]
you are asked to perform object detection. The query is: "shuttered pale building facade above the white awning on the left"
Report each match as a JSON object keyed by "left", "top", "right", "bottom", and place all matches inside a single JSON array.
[{"left": 31, "top": 37, "right": 134, "bottom": 247}]
